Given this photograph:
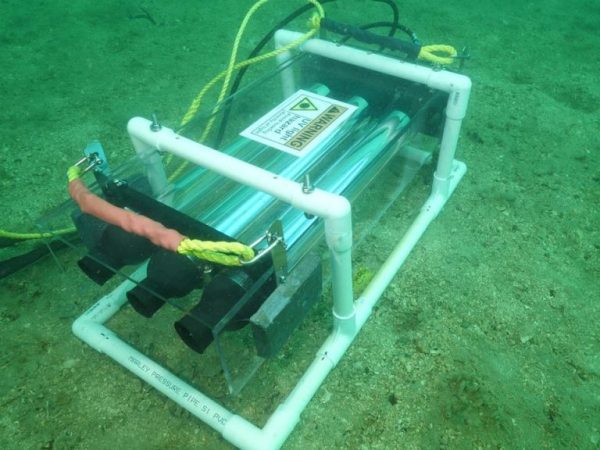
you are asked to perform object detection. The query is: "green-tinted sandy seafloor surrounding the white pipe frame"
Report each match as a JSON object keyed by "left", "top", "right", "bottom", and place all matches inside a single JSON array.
[{"left": 0, "top": 0, "right": 600, "bottom": 449}]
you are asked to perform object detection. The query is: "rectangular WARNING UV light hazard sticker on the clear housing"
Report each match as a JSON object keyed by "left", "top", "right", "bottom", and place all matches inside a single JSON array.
[{"left": 240, "top": 90, "right": 356, "bottom": 156}]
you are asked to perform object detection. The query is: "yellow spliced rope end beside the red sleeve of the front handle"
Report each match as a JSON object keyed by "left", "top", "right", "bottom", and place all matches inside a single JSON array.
[{"left": 177, "top": 238, "right": 254, "bottom": 266}]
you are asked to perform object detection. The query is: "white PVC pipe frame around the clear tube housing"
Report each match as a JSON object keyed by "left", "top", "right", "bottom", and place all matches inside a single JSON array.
[{"left": 73, "top": 30, "right": 471, "bottom": 450}]
